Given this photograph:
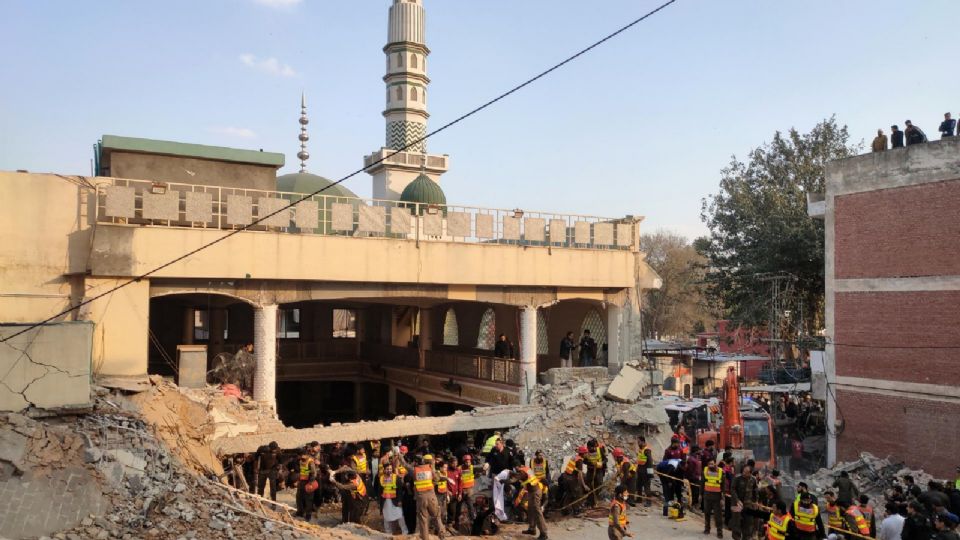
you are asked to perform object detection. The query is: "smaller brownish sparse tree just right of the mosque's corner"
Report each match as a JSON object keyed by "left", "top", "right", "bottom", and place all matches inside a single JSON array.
[{"left": 640, "top": 231, "right": 713, "bottom": 338}]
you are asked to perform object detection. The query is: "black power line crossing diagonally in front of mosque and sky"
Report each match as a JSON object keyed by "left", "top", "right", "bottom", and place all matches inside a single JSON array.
[{"left": 0, "top": 0, "right": 677, "bottom": 343}]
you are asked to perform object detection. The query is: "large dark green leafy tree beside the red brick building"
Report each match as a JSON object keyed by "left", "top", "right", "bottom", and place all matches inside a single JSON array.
[{"left": 700, "top": 117, "right": 862, "bottom": 332}]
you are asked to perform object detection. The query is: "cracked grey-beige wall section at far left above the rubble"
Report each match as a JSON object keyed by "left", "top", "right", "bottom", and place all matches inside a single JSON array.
[{"left": 0, "top": 322, "right": 93, "bottom": 412}]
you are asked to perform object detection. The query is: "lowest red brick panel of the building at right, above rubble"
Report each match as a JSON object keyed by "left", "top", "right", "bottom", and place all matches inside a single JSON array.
[{"left": 836, "top": 388, "right": 960, "bottom": 478}]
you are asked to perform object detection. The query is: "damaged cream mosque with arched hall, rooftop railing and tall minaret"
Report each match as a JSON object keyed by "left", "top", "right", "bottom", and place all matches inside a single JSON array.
[{"left": 0, "top": 0, "right": 659, "bottom": 427}]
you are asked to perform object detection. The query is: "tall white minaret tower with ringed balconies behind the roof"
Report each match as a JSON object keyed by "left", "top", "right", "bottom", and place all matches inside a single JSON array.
[{"left": 364, "top": 0, "right": 449, "bottom": 200}]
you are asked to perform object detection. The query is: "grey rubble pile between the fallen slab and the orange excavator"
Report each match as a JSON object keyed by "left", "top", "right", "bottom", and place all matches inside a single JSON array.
[{"left": 504, "top": 368, "right": 671, "bottom": 470}]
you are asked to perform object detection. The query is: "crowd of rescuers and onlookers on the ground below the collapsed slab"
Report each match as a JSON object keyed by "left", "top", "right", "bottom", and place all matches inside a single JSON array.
[{"left": 225, "top": 432, "right": 960, "bottom": 540}]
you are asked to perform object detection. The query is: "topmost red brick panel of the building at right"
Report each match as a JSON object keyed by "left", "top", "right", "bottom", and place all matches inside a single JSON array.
[{"left": 834, "top": 180, "right": 960, "bottom": 279}]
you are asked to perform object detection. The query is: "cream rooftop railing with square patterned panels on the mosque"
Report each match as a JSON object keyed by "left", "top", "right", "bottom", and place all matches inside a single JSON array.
[{"left": 96, "top": 178, "right": 639, "bottom": 250}]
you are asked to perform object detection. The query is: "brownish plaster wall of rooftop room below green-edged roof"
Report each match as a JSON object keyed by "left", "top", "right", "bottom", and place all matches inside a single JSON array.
[{"left": 109, "top": 150, "right": 277, "bottom": 191}]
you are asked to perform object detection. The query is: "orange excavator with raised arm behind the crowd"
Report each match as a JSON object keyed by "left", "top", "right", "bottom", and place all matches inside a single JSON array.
[{"left": 697, "top": 367, "right": 777, "bottom": 468}]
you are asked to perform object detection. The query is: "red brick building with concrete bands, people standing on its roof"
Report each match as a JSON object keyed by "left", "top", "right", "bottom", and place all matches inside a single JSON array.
[{"left": 810, "top": 138, "right": 960, "bottom": 477}]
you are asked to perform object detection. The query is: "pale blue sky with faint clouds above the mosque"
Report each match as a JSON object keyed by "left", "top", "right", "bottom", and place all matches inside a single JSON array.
[{"left": 0, "top": 0, "right": 960, "bottom": 238}]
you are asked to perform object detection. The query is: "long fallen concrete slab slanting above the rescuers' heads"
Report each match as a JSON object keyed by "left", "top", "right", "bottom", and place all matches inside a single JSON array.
[{"left": 212, "top": 405, "right": 539, "bottom": 455}]
